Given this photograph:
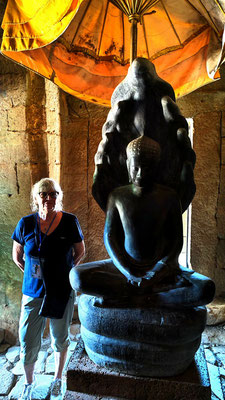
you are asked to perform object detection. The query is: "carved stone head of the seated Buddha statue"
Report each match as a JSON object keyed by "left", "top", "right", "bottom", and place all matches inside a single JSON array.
[{"left": 127, "top": 136, "right": 160, "bottom": 187}]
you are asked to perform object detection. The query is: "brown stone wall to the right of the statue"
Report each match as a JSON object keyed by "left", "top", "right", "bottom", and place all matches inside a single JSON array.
[{"left": 178, "top": 66, "right": 225, "bottom": 297}]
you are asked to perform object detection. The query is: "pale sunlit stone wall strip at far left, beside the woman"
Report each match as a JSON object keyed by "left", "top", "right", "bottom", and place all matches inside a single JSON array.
[{"left": 0, "top": 61, "right": 30, "bottom": 336}]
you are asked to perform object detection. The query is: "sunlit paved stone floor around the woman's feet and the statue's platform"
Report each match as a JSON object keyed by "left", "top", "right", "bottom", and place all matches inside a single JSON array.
[{"left": 0, "top": 324, "right": 225, "bottom": 400}]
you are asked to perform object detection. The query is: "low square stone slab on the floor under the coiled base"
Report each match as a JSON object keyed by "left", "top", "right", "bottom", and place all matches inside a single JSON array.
[{"left": 65, "top": 340, "right": 211, "bottom": 400}]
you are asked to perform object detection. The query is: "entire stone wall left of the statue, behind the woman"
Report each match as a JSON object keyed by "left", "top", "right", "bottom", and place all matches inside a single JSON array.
[{"left": 0, "top": 56, "right": 108, "bottom": 341}]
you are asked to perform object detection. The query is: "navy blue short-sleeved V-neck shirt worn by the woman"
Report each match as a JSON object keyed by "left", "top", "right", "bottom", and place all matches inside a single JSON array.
[{"left": 12, "top": 212, "right": 83, "bottom": 298}]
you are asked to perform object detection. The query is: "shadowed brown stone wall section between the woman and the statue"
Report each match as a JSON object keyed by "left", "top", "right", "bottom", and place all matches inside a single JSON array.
[{"left": 60, "top": 91, "right": 109, "bottom": 261}]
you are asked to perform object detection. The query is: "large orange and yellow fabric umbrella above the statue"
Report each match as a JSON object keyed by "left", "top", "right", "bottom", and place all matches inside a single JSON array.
[{"left": 1, "top": 0, "right": 225, "bottom": 106}]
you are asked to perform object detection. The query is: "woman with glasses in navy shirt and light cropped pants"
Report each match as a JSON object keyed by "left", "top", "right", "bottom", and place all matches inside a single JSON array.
[{"left": 12, "top": 178, "right": 85, "bottom": 400}]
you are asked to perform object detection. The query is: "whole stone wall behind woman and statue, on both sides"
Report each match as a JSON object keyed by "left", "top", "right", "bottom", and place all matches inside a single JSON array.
[{"left": 0, "top": 51, "right": 225, "bottom": 341}]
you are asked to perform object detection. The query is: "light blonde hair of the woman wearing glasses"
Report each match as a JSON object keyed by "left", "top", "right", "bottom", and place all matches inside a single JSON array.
[{"left": 30, "top": 178, "right": 63, "bottom": 211}]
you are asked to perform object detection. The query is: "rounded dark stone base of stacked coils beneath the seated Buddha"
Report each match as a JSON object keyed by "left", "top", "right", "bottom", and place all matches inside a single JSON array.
[{"left": 78, "top": 294, "right": 206, "bottom": 378}]
